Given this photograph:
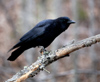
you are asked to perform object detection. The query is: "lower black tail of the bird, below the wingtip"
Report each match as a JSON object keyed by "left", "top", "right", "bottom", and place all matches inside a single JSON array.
[{"left": 7, "top": 47, "right": 25, "bottom": 61}]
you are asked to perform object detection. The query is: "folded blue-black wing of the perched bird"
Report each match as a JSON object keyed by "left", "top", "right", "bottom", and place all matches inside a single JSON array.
[{"left": 20, "top": 20, "right": 52, "bottom": 41}]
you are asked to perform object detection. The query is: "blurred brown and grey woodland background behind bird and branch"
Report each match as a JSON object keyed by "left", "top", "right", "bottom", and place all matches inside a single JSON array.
[{"left": 0, "top": 0, "right": 100, "bottom": 82}]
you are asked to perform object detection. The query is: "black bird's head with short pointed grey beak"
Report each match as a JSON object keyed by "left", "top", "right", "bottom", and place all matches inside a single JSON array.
[{"left": 56, "top": 17, "right": 75, "bottom": 30}]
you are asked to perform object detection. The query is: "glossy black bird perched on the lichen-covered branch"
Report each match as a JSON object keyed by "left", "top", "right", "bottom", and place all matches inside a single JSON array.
[{"left": 8, "top": 17, "right": 75, "bottom": 61}]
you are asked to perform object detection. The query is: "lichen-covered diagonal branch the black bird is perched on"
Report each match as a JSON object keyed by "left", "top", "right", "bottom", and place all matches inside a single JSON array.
[{"left": 5, "top": 34, "right": 100, "bottom": 82}]
